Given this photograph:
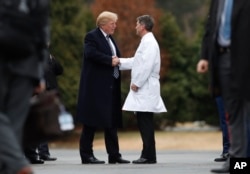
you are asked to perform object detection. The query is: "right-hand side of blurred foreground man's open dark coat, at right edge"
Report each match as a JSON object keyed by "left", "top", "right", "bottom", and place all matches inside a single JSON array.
[{"left": 231, "top": 0, "right": 250, "bottom": 101}]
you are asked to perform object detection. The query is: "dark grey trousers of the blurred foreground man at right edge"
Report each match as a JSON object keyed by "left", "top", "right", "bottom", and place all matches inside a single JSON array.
[{"left": 219, "top": 52, "right": 250, "bottom": 158}]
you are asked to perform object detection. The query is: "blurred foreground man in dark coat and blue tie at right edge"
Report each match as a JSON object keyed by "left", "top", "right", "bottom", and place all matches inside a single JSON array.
[{"left": 197, "top": 0, "right": 250, "bottom": 173}]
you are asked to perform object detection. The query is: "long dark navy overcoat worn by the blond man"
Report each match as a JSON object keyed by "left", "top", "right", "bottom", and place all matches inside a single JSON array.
[{"left": 77, "top": 28, "right": 122, "bottom": 128}]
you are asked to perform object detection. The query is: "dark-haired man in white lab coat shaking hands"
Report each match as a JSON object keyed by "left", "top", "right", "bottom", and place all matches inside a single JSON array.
[{"left": 120, "top": 15, "right": 167, "bottom": 164}]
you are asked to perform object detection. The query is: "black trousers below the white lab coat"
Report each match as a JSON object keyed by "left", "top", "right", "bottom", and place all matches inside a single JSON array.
[{"left": 136, "top": 112, "right": 156, "bottom": 160}]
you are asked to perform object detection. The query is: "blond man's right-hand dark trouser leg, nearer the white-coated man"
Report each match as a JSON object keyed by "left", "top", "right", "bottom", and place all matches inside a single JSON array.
[{"left": 104, "top": 128, "right": 121, "bottom": 159}]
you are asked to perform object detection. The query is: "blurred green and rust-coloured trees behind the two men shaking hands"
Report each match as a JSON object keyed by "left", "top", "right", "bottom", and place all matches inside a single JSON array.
[{"left": 50, "top": 0, "right": 218, "bottom": 129}]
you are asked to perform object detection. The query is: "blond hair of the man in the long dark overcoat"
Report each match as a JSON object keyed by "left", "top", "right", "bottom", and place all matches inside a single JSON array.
[{"left": 96, "top": 11, "right": 118, "bottom": 27}]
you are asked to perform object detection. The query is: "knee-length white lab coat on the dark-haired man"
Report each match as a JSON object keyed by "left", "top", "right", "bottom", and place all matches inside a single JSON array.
[{"left": 120, "top": 32, "right": 167, "bottom": 113}]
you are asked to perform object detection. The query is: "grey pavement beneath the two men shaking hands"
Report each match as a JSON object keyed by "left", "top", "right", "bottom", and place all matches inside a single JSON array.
[{"left": 33, "top": 149, "right": 225, "bottom": 174}]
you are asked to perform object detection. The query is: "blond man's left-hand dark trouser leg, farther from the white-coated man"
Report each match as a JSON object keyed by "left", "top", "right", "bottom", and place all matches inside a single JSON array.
[{"left": 80, "top": 125, "right": 96, "bottom": 159}]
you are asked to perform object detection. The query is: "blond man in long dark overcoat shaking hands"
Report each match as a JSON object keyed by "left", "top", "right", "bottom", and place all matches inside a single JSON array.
[{"left": 77, "top": 11, "right": 129, "bottom": 164}]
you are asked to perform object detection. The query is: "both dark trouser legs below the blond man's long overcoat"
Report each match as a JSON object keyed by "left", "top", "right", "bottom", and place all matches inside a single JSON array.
[{"left": 80, "top": 125, "right": 121, "bottom": 159}]
